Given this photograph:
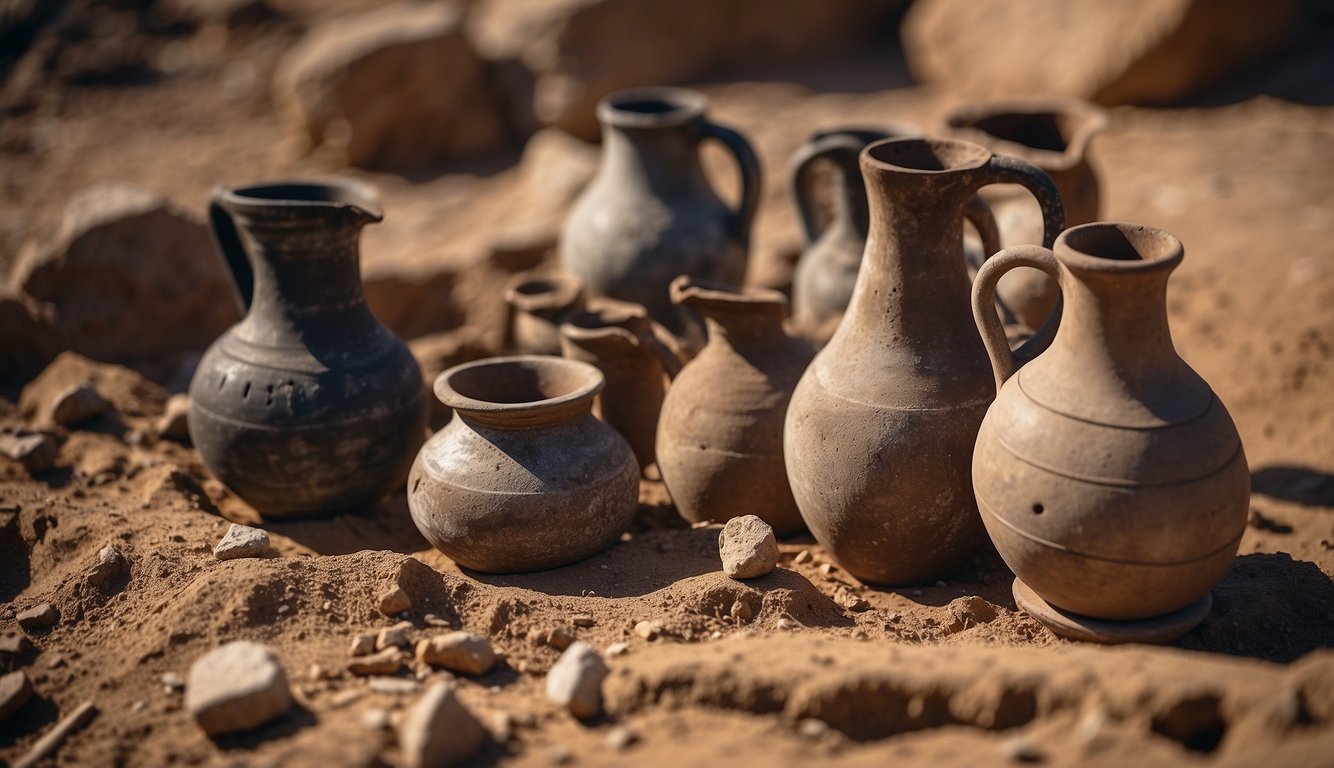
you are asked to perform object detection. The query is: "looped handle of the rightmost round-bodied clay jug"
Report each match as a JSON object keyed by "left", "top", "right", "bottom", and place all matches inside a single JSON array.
[{"left": 972, "top": 245, "right": 1061, "bottom": 392}]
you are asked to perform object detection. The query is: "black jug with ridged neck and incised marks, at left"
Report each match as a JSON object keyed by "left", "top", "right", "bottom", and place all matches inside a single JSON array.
[{"left": 189, "top": 183, "right": 427, "bottom": 517}]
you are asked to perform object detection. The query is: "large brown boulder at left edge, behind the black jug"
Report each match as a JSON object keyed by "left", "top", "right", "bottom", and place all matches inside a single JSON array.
[{"left": 11, "top": 185, "right": 237, "bottom": 363}]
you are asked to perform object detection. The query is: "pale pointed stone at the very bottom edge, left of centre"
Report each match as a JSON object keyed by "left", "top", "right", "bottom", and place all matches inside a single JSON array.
[{"left": 398, "top": 681, "right": 491, "bottom": 768}]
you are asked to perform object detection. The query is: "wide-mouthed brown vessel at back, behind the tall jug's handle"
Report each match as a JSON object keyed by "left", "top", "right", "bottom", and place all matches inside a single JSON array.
[{"left": 944, "top": 99, "right": 1107, "bottom": 329}]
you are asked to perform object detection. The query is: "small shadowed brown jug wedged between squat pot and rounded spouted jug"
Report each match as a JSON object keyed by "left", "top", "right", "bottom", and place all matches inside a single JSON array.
[{"left": 560, "top": 299, "right": 680, "bottom": 469}]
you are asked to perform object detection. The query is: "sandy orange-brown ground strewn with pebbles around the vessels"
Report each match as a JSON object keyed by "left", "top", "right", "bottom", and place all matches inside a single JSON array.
[{"left": 0, "top": 22, "right": 1334, "bottom": 765}]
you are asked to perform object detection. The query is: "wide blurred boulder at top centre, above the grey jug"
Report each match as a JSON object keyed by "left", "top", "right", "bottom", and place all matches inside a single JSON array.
[{"left": 470, "top": 0, "right": 906, "bottom": 139}]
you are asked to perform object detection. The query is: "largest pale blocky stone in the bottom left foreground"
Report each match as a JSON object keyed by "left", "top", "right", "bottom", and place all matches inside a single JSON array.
[{"left": 185, "top": 640, "right": 292, "bottom": 736}]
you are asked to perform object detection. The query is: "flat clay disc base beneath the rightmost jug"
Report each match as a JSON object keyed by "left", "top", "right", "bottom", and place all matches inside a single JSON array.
[{"left": 1013, "top": 579, "right": 1214, "bottom": 644}]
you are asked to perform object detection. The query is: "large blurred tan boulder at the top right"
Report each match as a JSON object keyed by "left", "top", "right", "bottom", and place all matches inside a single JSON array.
[{"left": 902, "top": 0, "right": 1299, "bottom": 104}]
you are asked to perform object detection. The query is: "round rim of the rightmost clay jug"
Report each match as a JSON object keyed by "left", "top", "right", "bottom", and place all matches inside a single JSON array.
[{"left": 1053, "top": 221, "right": 1186, "bottom": 275}]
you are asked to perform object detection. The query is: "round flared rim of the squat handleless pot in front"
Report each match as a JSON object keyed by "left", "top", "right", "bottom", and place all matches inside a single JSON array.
[{"left": 432, "top": 355, "right": 606, "bottom": 416}]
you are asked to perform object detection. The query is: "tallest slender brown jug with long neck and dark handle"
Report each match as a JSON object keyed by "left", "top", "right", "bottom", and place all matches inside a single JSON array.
[{"left": 783, "top": 139, "right": 1062, "bottom": 584}]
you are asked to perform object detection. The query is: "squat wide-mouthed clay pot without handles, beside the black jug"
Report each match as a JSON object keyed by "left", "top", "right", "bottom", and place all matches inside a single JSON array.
[{"left": 408, "top": 355, "right": 639, "bottom": 573}]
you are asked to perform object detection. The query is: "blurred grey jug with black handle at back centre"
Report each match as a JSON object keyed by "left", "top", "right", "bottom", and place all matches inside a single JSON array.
[{"left": 560, "top": 88, "right": 760, "bottom": 335}]
